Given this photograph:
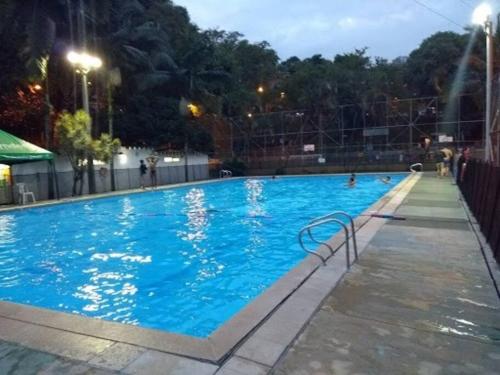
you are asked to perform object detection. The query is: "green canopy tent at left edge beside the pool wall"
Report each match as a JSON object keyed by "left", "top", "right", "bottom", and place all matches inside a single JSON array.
[{"left": 0, "top": 129, "right": 59, "bottom": 201}]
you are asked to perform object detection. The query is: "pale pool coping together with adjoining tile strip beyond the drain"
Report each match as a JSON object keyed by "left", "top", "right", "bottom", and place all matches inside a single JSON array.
[{"left": 0, "top": 174, "right": 420, "bottom": 369}]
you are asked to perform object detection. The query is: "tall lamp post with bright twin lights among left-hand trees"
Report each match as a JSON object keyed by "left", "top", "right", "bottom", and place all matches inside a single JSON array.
[{"left": 66, "top": 51, "right": 102, "bottom": 194}]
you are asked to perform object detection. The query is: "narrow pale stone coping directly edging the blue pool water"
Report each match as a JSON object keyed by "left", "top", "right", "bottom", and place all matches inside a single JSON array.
[{"left": 0, "top": 173, "right": 420, "bottom": 364}]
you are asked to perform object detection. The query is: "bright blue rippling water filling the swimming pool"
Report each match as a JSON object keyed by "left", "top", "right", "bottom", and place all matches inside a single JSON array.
[{"left": 0, "top": 174, "right": 405, "bottom": 337}]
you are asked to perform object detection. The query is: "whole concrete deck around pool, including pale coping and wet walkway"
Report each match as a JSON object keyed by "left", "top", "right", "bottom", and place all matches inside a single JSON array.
[{"left": 0, "top": 175, "right": 500, "bottom": 375}]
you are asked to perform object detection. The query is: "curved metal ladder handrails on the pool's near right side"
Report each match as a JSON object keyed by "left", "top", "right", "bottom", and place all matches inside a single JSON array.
[{"left": 299, "top": 211, "right": 358, "bottom": 269}]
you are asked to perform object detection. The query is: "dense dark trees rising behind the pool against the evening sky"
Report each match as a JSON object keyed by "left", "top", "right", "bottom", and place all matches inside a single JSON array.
[{"left": 0, "top": 0, "right": 500, "bottom": 151}]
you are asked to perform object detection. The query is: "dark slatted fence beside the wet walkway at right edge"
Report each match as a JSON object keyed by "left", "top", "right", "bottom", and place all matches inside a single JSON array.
[{"left": 460, "top": 160, "right": 500, "bottom": 263}]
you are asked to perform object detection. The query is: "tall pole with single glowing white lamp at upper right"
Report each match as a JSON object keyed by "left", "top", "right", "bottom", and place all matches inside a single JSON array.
[{"left": 472, "top": 3, "right": 493, "bottom": 161}]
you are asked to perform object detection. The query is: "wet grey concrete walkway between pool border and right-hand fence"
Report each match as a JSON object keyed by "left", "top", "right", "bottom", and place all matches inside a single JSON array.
[{"left": 274, "top": 176, "right": 500, "bottom": 375}]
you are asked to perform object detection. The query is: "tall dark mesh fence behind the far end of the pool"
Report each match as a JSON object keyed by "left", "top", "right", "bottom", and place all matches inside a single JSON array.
[{"left": 218, "top": 95, "right": 484, "bottom": 168}]
